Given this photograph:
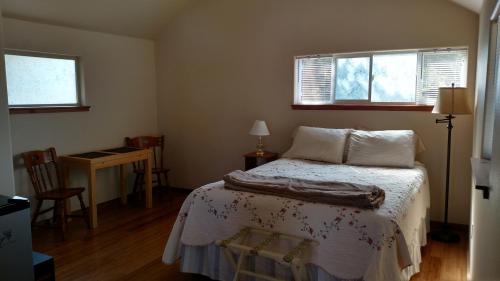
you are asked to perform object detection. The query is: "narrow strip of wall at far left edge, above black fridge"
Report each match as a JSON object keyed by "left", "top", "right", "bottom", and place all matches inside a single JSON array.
[{"left": 0, "top": 10, "right": 16, "bottom": 196}]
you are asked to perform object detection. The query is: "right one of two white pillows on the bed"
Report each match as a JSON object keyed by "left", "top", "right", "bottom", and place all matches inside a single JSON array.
[{"left": 346, "top": 130, "right": 417, "bottom": 168}]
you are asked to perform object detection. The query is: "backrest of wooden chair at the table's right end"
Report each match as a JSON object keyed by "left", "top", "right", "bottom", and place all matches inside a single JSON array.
[{"left": 125, "top": 135, "right": 165, "bottom": 169}]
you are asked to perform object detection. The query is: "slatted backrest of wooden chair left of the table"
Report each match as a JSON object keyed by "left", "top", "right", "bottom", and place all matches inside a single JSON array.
[{"left": 22, "top": 147, "right": 62, "bottom": 195}]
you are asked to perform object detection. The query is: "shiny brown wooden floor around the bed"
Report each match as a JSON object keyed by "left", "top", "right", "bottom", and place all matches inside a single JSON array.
[{"left": 33, "top": 190, "right": 467, "bottom": 281}]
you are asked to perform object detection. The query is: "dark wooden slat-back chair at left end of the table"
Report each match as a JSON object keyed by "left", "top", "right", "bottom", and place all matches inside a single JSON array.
[{"left": 22, "top": 147, "right": 90, "bottom": 239}]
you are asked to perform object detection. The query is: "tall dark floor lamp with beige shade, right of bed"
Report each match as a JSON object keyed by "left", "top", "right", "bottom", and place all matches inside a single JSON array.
[{"left": 431, "top": 84, "right": 472, "bottom": 243}]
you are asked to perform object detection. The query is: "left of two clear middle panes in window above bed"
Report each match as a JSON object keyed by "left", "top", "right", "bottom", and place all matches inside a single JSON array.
[{"left": 335, "top": 57, "right": 370, "bottom": 100}]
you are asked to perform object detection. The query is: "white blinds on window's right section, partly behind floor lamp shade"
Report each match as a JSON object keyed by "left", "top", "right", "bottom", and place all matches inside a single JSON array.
[{"left": 417, "top": 49, "right": 467, "bottom": 105}]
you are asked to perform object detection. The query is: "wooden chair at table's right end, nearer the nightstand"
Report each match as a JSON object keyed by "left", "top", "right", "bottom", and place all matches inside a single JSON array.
[{"left": 125, "top": 135, "right": 170, "bottom": 193}]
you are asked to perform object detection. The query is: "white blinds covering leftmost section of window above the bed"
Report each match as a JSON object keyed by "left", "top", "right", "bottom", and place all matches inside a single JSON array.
[{"left": 295, "top": 57, "right": 334, "bottom": 104}]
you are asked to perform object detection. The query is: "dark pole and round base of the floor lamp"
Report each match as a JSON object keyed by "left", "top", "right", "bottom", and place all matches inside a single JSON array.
[{"left": 431, "top": 114, "right": 459, "bottom": 243}]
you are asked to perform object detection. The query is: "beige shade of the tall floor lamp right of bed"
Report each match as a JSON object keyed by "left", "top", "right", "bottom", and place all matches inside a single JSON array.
[{"left": 432, "top": 87, "right": 472, "bottom": 115}]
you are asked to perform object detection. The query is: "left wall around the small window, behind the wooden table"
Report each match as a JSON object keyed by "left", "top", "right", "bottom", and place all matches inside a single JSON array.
[{"left": 4, "top": 19, "right": 157, "bottom": 205}]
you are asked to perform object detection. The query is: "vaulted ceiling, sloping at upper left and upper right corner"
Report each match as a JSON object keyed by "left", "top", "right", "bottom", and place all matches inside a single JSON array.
[{"left": 0, "top": 0, "right": 484, "bottom": 39}]
